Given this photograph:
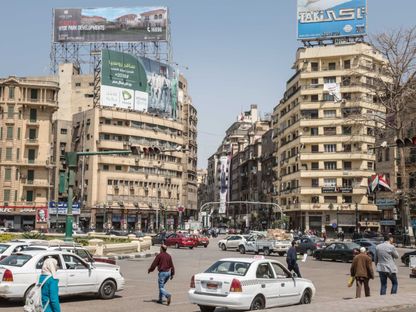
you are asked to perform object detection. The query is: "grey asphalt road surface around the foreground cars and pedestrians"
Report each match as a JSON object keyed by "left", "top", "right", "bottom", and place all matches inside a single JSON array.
[{"left": 0, "top": 239, "right": 416, "bottom": 312}]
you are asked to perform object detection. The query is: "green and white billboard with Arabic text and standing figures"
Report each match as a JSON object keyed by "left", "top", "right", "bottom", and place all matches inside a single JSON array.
[{"left": 100, "top": 50, "right": 178, "bottom": 119}]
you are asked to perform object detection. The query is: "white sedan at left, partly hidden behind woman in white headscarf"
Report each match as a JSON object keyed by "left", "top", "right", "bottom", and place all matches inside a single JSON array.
[{"left": 0, "top": 250, "right": 125, "bottom": 299}]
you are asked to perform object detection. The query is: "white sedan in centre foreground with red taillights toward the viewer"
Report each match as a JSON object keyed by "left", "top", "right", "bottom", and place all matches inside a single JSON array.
[{"left": 188, "top": 256, "right": 316, "bottom": 312}]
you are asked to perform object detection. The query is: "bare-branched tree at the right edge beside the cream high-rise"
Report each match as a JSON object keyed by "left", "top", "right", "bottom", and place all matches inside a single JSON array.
[{"left": 350, "top": 27, "right": 416, "bottom": 243}]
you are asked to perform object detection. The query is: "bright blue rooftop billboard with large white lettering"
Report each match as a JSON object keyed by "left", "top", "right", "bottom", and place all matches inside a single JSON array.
[{"left": 297, "top": 0, "right": 367, "bottom": 40}]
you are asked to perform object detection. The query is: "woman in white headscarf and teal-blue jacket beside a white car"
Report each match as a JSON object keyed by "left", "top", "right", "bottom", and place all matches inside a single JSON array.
[{"left": 39, "top": 258, "right": 61, "bottom": 312}]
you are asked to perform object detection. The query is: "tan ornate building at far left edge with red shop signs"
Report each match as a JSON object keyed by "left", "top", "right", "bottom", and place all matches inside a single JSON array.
[{"left": 0, "top": 77, "right": 59, "bottom": 229}]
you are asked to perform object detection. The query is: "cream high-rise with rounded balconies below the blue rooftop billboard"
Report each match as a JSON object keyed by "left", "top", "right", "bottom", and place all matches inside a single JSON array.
[{"left": 274, "top": 43, "right": 384, "bottom": 232}]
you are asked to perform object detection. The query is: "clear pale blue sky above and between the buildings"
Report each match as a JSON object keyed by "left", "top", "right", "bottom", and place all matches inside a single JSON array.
[{"left": 0, "top": 0, "right": 416, "bottom": 167}]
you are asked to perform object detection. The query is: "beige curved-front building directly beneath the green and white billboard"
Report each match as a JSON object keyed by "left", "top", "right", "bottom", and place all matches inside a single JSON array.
[{"left": 72, "top": 73, "right": 197, "bottom": 231}]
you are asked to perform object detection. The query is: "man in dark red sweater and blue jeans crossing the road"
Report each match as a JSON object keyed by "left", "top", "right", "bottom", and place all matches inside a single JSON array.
[{"left": 147, "top": 245, "right": 175, "bottom": 305}]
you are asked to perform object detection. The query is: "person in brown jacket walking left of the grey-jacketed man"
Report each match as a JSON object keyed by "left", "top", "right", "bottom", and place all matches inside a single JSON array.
[{"left": 350, "top": 247, "right": 374, "bottom": 298}]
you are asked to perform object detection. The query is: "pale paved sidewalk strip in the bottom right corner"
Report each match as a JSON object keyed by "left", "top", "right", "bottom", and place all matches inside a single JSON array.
[{"left": 268, "top": 292, "right": 416, "bottom": 312}]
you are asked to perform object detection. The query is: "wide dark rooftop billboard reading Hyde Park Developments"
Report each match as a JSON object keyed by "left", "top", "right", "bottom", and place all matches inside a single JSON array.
[{"left": 53, "top": 7, "right": 168, "bottom": 42}]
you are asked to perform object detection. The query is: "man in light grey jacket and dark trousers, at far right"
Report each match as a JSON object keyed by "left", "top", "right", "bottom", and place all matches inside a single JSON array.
[{"left": 374, "top": 235, "right": 399, "bottom": 295}]
